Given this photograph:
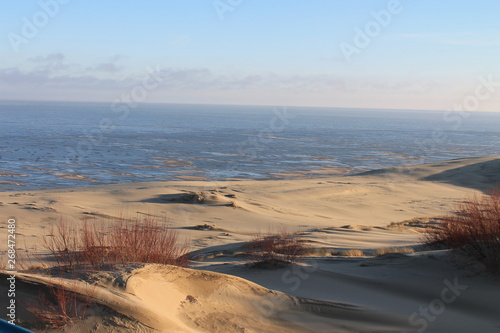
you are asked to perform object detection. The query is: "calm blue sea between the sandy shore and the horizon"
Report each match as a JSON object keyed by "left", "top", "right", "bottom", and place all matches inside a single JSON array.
[{"left": 0, "top": 102, "right": 500, "bottom": 191}]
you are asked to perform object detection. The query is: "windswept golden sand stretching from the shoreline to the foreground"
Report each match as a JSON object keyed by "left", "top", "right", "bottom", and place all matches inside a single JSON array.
[{"left": 0, "top": 156, "right": 500, "bottom": 332}]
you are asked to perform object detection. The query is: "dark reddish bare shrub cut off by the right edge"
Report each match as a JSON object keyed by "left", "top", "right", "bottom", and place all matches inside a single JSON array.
[{"left": 423, "top": 188, "right": 500, "bottom": 271}]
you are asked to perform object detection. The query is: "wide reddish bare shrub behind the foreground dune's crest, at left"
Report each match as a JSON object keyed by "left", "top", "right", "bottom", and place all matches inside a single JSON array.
[{"left": 44, "top": 217, "right": 189, "bottom": 268}]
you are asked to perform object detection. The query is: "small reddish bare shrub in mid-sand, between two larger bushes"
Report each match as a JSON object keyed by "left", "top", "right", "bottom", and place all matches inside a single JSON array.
[{"left": 246, "top": 230, "right": 305, "bottom": 267}]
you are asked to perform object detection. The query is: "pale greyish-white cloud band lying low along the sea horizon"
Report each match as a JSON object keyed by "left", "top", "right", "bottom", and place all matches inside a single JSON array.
[{"left": 0, "top": 54, "right": 496, "bottom": 109}]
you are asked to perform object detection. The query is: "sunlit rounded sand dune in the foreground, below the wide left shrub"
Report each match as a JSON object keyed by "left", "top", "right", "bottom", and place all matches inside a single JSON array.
[{"left": 0, "top": 264, "right": 414, "bottom": 332}]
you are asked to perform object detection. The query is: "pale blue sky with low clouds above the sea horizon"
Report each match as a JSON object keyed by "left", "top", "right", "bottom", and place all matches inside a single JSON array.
[{"left": 0, "top": 0, "right": 500, "bottom": 112}]
